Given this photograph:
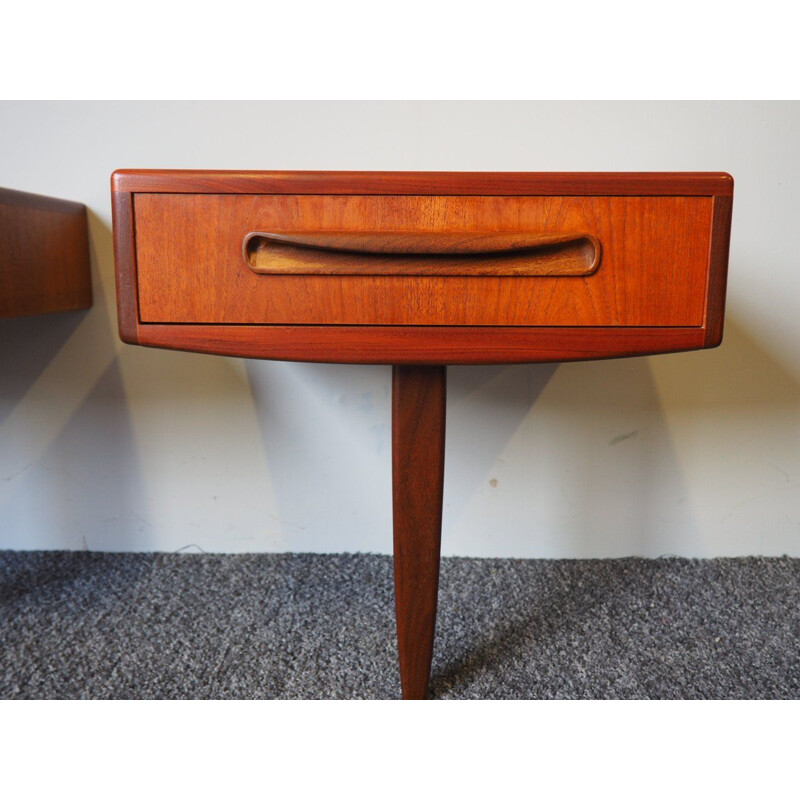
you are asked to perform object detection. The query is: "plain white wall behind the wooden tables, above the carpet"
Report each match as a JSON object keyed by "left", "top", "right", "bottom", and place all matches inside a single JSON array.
[{"left": 0, "top": 102, "right": 800, "bottom": 557}]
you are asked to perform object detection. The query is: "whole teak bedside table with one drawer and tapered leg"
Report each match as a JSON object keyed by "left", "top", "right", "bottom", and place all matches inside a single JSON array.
[{"left": 111, "top": 170, "right": 733, "bottom": 699}]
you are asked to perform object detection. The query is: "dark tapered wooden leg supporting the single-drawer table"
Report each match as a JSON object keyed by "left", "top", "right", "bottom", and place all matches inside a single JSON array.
[{"left": 392, "top": 366, "right": 447, "bottom": 700}]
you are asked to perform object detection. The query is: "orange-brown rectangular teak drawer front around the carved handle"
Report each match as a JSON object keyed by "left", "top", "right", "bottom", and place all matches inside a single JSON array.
[{"left": 133, "top": 193, "right": 713, "bottom": 327}]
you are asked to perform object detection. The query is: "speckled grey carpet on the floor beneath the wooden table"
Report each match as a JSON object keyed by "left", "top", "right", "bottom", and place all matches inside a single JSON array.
[{"left": 0, "top": 552, "right": 800, "bottom": 698}]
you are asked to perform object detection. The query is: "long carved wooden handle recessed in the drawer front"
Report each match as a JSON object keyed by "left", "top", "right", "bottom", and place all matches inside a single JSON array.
[{"left": 242, "top": 231, "right": 600, "bottom": 277}]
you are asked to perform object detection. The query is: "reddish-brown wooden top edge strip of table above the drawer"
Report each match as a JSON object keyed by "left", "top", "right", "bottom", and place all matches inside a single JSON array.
[{"left": 111, "top": 169, "right": 733, "bottom": 197}]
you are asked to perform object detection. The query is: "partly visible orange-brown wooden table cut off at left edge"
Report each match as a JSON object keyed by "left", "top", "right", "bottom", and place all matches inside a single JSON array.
[{"left": 0, "top": 189, "right": 92, "bottom": 317}]
